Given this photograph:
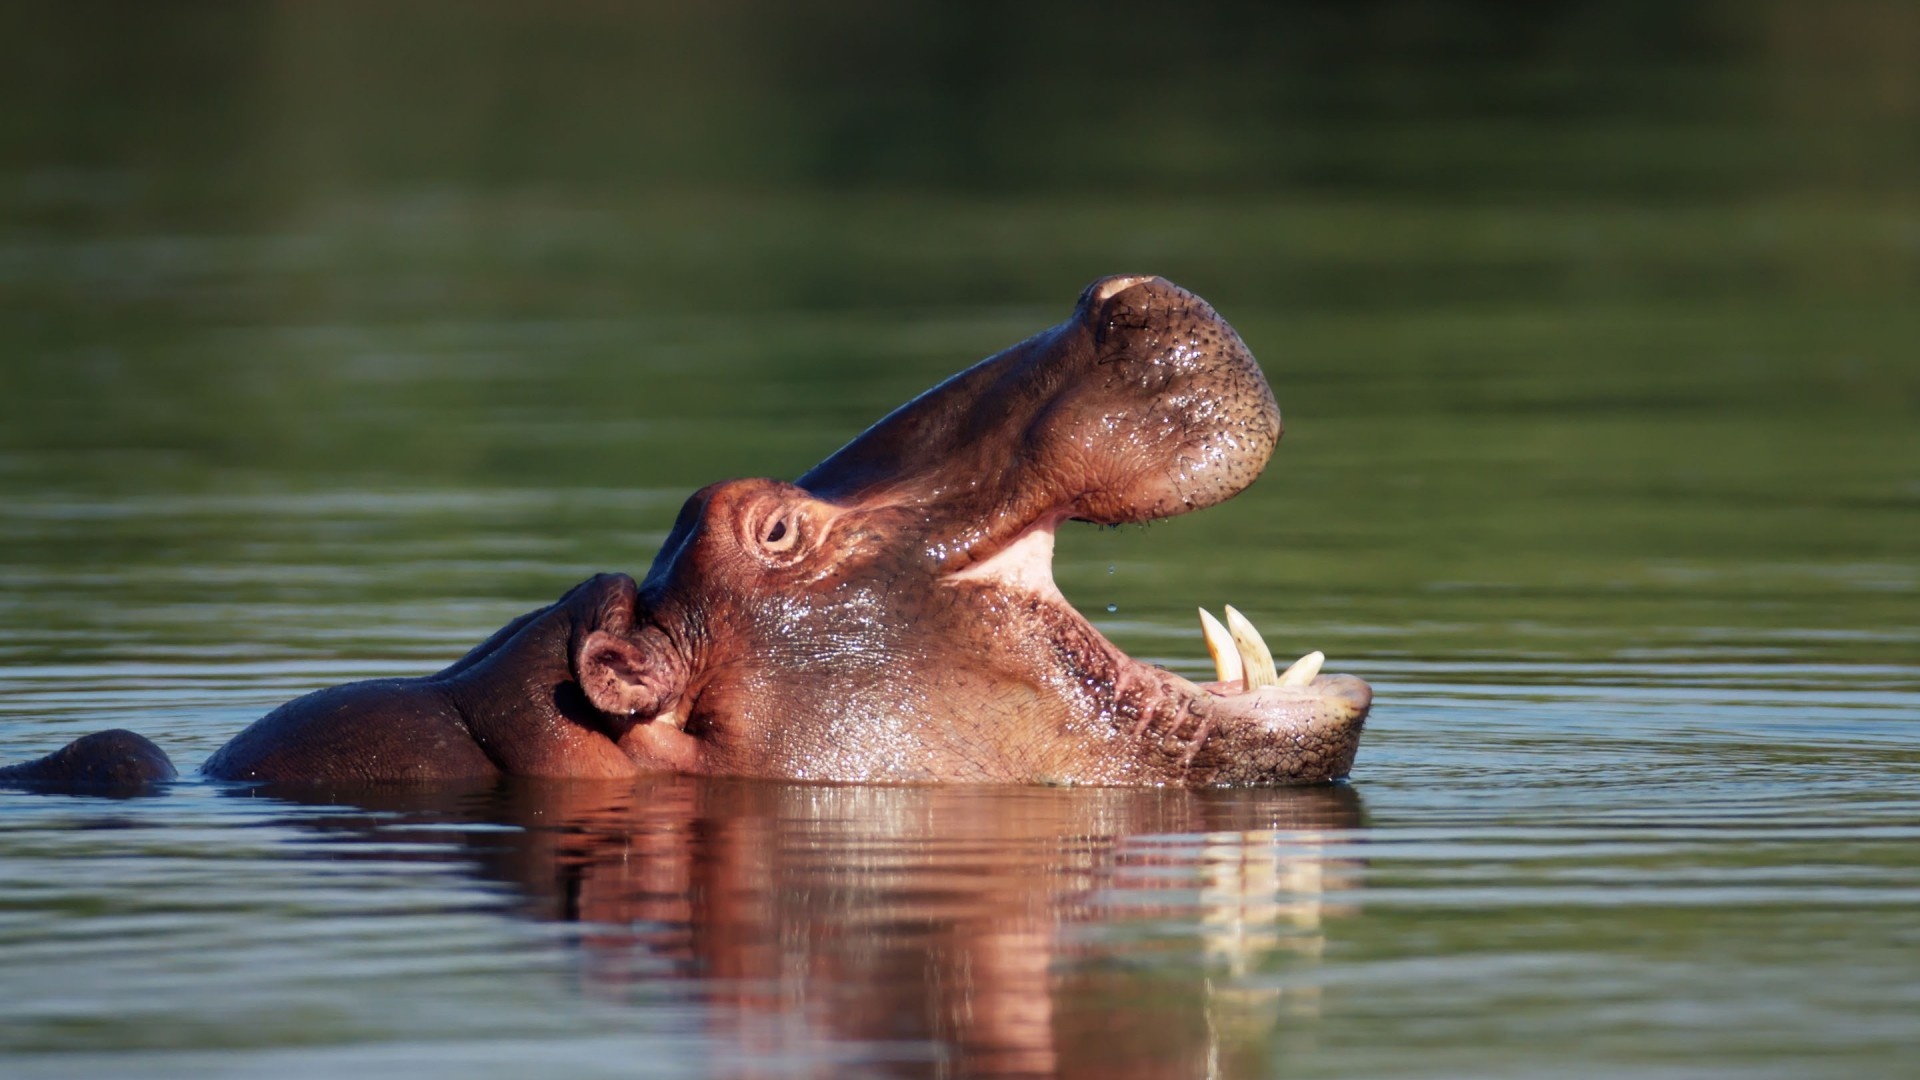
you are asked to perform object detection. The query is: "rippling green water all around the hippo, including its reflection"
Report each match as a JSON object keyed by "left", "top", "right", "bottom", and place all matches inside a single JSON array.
[{"left": 0, "top": 2, "right": 1920, "bottom": 1076}]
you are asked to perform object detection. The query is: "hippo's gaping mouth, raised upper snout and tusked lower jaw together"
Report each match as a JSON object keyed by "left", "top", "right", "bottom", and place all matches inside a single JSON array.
[{"left": 797, "top": 275, "right": 1371, "bottom": 784}]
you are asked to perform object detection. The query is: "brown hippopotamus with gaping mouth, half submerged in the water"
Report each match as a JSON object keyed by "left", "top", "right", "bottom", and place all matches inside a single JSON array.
[{"left": 0, "top": 275, "right": 1371, "bottom": 786}]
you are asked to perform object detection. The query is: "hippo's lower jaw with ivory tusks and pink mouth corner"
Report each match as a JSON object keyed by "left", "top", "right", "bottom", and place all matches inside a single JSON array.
[{"left": 947, "top": 511, "right": 1373, "bottom": 786}]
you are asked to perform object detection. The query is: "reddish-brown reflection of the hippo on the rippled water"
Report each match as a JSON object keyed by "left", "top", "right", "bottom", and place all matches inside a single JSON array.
[{"left": 263, "top": 776, "right": 1367, "bottom": 1080}]
